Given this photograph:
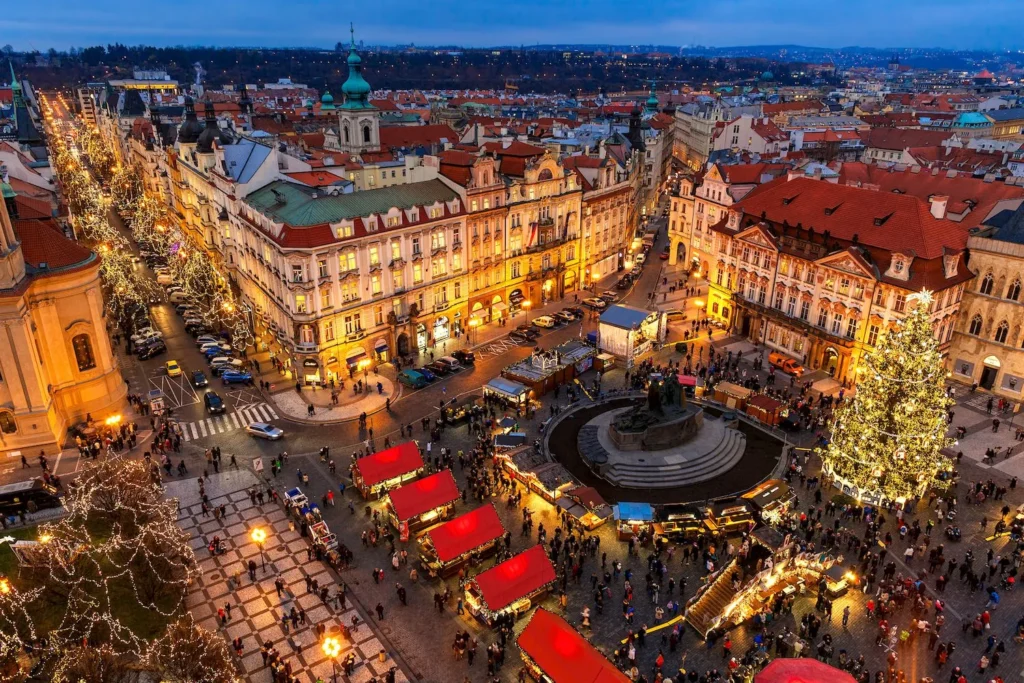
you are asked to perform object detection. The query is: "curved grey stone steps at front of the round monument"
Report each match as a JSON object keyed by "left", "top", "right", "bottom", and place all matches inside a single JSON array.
[{"left": 605, "top": 429, "right": 746, "bottom": 488}]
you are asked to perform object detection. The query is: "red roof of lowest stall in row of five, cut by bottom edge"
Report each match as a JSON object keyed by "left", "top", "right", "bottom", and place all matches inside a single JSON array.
[{"left": 518, "top": 609, "right": 629, "bottom": 683}]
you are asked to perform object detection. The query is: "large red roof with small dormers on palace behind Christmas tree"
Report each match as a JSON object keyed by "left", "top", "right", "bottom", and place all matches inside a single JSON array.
[{"left": 739, "top": 178, "right": 968, "bottom": 259}]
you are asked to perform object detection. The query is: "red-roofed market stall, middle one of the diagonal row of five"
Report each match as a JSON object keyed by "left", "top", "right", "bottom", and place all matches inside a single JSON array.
[{"left": 420, "top": 503, "right": 505, "bottom": 578}]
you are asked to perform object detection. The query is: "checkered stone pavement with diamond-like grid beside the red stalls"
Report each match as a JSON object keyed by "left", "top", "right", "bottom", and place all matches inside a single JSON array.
[{"left": 167, "top": 471, "right": 408, "bottom": 683}]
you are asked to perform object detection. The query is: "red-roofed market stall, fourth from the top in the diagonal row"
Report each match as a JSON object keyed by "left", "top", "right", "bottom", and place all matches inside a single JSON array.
[{"left": 466, "top": 546, "right": 555, "bottom": 626}]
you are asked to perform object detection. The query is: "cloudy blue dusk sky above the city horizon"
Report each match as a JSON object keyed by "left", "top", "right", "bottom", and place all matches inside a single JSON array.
[{"left": 0, "top": 0, "right": 1024, "bottom": 51}]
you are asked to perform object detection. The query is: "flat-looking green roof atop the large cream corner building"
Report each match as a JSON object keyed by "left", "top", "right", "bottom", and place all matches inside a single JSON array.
[{"left": 246, "top": 180, "right": 459, "bottom": 227}]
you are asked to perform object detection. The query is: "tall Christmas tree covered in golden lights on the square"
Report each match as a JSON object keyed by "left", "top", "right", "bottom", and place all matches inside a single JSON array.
[{"left": 818, "top": 291, "right": 952, "bottom": 501}]
